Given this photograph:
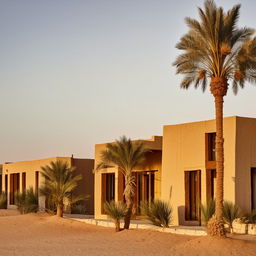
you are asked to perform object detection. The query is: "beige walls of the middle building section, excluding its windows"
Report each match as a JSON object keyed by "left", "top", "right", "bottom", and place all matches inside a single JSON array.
[{"left": 94, "top": 136, "right": 162, "bottom": 219}]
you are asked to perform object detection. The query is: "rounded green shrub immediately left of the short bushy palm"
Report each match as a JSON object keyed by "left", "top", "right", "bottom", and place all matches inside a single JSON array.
[{"left": 15, "top": 188, "right": 38, "bottom": 214}]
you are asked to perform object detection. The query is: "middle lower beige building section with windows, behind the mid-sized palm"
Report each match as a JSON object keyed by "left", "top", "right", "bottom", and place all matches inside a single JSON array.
[{"left": 94, "top": 136, "right": 162, "bottom": 219}]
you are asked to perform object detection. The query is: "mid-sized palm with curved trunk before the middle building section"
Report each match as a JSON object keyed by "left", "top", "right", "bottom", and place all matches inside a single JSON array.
[{"left": 96, "top": 136, "right": 148, "bottom": 229}]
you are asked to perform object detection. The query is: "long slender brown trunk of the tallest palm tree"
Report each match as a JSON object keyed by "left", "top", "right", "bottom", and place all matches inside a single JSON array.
[{"left": 215, "top": 96, "right": 224, "bottom": 220}]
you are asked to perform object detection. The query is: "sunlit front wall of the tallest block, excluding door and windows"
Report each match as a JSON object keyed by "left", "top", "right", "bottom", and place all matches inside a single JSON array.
[{"left": 161, "top": 117, "right": 236, "bottom": 225}]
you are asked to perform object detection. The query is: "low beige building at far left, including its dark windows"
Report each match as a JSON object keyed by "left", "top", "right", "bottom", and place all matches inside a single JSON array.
[{"left": 1, "top": 157, "right": 94, "bottom": 214}]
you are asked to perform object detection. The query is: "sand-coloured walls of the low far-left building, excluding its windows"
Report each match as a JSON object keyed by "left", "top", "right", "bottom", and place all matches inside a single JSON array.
[{"left": 2, "top": 157, "right": 94, "bottom": 212}]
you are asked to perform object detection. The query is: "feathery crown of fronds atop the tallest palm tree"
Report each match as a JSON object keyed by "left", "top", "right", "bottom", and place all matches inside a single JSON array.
[{"left": 173, "top": 0, "right": 256, "bottom": 93}]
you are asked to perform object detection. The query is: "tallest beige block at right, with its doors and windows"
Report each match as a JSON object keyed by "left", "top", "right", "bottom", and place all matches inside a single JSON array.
[{"left": 161, "top": 116, "right": 256, "bottom": 225}]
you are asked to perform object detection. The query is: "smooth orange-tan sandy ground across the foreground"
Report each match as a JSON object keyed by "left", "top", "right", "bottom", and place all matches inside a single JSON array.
[{"left": 0, "top": 210, "right": 256, "bottom": 256}]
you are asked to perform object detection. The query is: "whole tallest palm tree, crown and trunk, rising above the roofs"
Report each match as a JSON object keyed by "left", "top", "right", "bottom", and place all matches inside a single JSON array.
[{"left": 173, "top": 0, "right": 256, "bottom": 235}]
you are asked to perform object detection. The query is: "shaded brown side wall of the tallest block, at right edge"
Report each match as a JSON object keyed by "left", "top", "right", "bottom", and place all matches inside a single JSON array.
[{"left": 235, "top": 117, "right": 256, "bottom": 212}]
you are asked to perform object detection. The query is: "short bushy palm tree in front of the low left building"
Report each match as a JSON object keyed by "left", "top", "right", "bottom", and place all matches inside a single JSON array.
[{"left": 40, "top": 160, "right": 84, "bottom": 217}]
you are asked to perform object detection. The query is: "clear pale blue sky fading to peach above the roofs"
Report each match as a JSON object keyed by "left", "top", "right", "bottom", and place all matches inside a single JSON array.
[{"left": 0, "top": 0, "right": 256, "bottom": 163}]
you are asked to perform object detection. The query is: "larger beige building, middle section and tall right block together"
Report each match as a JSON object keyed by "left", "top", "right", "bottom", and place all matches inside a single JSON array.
[{"left": 95, "top": 116, "right": 256, "bottom": 225}]
